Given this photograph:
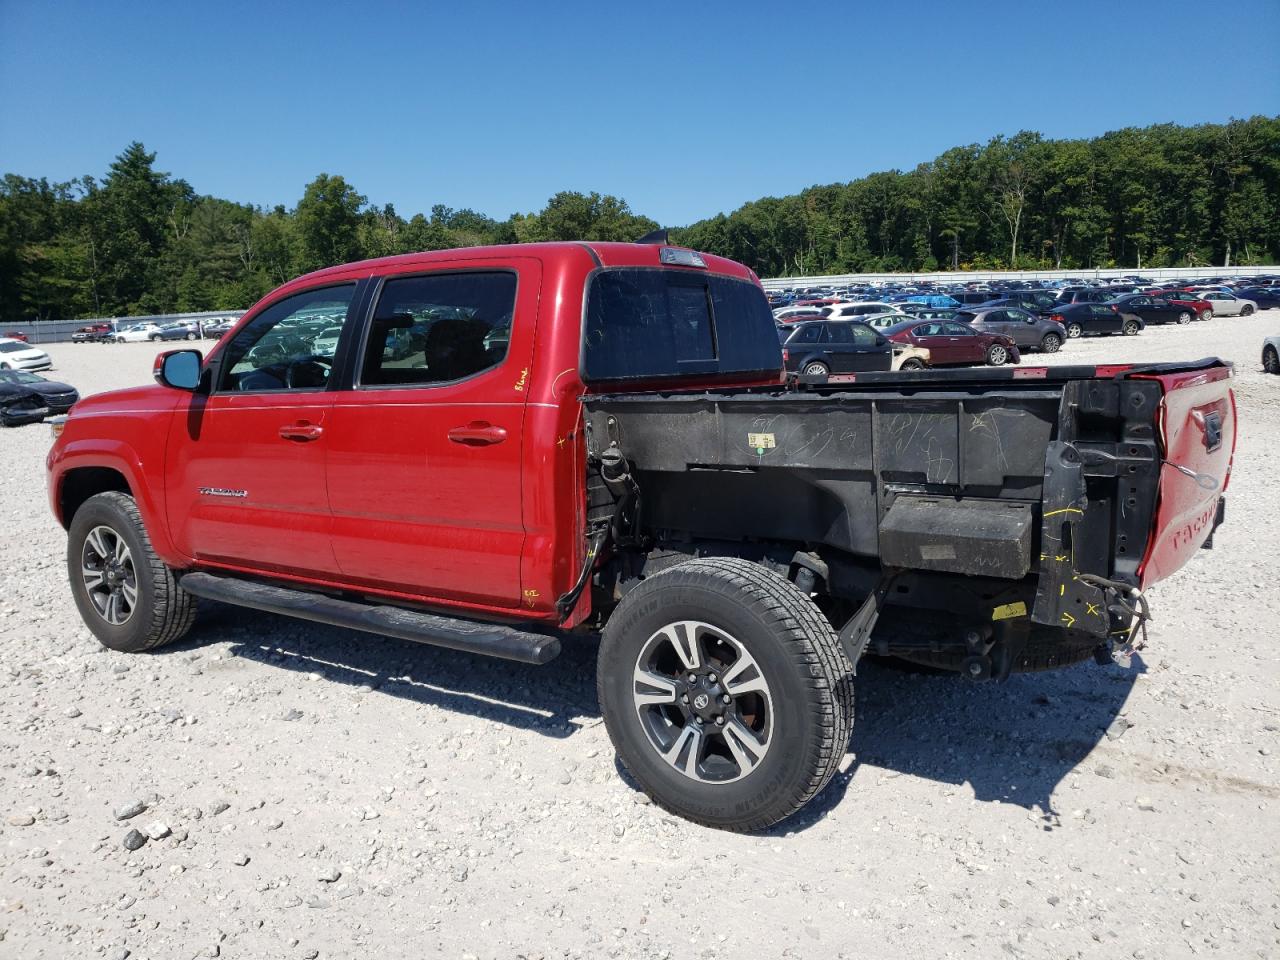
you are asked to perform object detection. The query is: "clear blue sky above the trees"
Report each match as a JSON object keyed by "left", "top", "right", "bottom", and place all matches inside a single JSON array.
[{"left": 0, "top": 0, "right": 1280, "bottom": 225}]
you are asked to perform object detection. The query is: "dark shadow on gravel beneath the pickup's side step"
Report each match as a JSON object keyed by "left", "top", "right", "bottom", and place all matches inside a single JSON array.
[{"left": 179, "top": 603, "right": 600, "bottom": 737}]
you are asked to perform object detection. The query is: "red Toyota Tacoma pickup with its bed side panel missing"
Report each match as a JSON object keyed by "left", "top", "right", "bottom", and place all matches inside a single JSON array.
[{"left": 47, "top": 242, "right": 1235, "bottom": 829}]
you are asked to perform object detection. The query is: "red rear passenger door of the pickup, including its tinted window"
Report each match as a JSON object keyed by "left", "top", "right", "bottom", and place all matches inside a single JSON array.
[{"left": 328, "top": 257, "right": 541, "bottom": 607}]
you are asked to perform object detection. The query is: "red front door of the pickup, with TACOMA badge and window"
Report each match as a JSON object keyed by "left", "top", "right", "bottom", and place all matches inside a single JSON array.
[{"left": 165, "top": 283, "right": 356, "bottom": 577}]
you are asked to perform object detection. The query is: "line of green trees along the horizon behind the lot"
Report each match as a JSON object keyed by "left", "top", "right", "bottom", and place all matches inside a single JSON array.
[{"left": 0, "top": 116, "right": 1280, "bottom": 321}]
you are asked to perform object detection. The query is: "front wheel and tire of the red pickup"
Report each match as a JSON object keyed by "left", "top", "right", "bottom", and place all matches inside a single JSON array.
[{"left": 67, "top": 492, "right": 196, "bottom": 653}]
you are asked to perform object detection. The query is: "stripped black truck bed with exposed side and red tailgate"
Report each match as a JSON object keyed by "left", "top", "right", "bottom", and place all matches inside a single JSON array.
[{"left": 585, "top": 360, "right": 1234, "bottom": 678}]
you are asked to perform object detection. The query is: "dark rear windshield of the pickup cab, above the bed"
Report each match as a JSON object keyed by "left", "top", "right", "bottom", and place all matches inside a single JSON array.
[{"left": 582, "top": 268, "right": 782, "bottom": 381}]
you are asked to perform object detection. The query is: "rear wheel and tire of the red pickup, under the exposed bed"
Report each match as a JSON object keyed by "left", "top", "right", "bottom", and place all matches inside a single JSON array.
[{"left": 596, "top": 558, "right": 854, "bottom": 831}]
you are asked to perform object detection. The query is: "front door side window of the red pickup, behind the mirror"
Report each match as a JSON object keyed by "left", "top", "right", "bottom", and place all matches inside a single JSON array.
[{"left": 220, "top": 284, "right": 356, "bottom": 392}]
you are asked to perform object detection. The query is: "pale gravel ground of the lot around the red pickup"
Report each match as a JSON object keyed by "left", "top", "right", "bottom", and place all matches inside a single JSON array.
[{"left": 0, "top": 320, "right": 1280, "bottom": 960}]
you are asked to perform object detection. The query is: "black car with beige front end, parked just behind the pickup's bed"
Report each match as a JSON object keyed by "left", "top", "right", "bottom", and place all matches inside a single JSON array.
[{"left": 778, "top": 320, "right": 929, "bottom": 376}]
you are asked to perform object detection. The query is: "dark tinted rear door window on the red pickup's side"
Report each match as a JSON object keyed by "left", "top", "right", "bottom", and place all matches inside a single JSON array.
[{"left": 360, "top": 270, "right": 516, "bottom": 387}]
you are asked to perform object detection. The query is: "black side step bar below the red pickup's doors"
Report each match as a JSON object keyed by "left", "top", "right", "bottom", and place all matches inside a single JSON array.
[{"left": 178, "top": 573, "right": 561, "bottom": 666}]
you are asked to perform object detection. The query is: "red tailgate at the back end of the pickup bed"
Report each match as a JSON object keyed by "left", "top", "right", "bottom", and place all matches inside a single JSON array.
[{"left": 1134, "top": 364, "right": 1235, "bottom": 588}]
